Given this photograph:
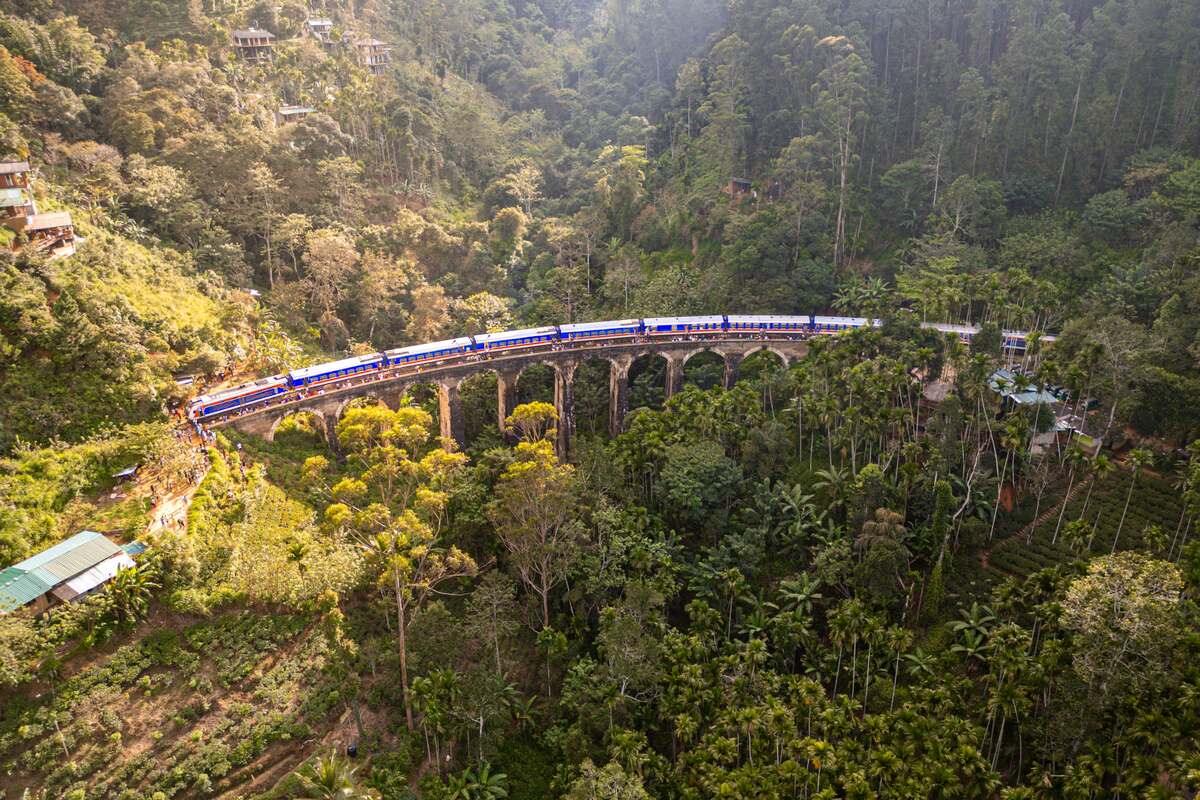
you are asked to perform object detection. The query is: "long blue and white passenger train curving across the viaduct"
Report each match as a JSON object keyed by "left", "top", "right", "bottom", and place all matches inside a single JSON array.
[{"left": 187, "top": 314, "right": 1054, "bottom": 422}]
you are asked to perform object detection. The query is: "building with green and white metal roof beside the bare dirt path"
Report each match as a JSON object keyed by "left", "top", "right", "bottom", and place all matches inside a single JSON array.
[{"left": 0, "top": 530, "right": 133, "bottom": 614}]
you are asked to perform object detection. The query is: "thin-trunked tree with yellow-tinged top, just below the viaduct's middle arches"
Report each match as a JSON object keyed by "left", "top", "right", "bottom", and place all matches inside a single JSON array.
[{"left": 488, "top": 440, "right": 582, "bottom": 630}]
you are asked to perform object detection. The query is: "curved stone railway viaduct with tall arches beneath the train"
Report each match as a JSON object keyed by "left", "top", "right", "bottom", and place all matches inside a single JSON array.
[{"left": 219, "top": 336, "right": 808, "bottom": 458}]
